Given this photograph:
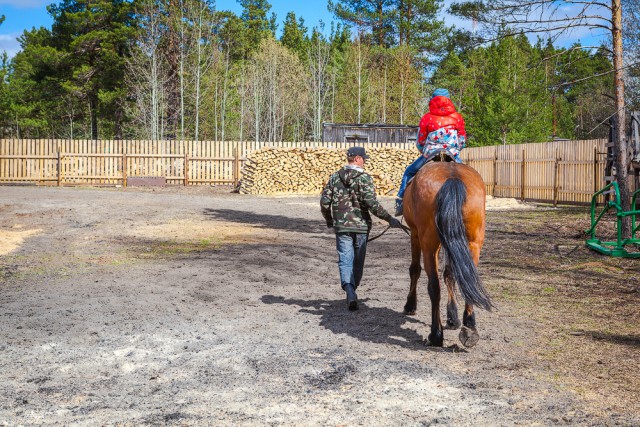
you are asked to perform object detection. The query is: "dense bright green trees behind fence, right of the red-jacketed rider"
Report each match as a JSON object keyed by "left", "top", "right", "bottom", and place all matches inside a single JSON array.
[{"left": 432, "top": 35, "right": 613, "bottom": 145}]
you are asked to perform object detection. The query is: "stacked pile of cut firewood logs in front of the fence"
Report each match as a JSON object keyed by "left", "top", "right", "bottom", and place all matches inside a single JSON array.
[{"left": 240, "top": 147, "right": 418, "bottom": 195}]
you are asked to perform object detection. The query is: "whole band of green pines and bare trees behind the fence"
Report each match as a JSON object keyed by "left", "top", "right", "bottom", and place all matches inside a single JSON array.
[{"left": 0, "top": 0, "right": 624, "bottom": 145}]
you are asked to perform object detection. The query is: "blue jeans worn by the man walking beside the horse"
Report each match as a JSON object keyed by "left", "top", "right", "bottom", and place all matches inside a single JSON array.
[{"left": 336, "top": 233, "right": 369, "bottom": 289}]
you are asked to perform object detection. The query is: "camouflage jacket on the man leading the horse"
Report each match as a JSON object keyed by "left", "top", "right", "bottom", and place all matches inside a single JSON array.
[{"left": 320, "top": 166, "right": 393, "bottom": 233}]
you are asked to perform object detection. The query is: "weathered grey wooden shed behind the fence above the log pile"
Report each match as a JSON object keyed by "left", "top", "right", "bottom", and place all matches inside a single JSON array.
[{"left": 322, "top": 123, "right": 418, "bottom": 144}]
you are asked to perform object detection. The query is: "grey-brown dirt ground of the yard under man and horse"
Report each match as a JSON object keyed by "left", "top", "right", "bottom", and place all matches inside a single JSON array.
[{"left": 0, "top": 187, "right": 640, "bottom": 426}]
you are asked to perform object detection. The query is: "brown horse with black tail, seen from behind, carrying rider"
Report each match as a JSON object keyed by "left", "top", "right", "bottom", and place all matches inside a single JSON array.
[{"left": 404, "top": 162, "right": 493, "bottom": 347}]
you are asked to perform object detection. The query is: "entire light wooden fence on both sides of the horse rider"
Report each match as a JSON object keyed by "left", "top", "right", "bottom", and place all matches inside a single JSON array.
[{"left": 0, "top": 140, "right": 606, "bottom": 203}]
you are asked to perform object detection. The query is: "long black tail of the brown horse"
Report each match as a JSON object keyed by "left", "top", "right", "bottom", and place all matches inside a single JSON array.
[{"left": 436, "top": 178, "right": 493, "bottom": 311}]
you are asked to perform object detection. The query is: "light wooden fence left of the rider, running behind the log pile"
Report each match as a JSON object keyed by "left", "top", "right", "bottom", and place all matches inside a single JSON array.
[{"left": 0, "top": 139, "right": 412, "bottom": 186}]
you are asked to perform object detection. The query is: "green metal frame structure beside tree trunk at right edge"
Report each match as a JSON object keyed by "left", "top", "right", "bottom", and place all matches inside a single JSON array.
[{"left": 585, "top": 181, "right": 640, "bottom": 258}]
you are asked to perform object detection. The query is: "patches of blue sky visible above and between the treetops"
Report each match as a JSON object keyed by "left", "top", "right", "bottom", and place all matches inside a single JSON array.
[{"left": 0, "top": 0, "right": 603, "bottom": 56}]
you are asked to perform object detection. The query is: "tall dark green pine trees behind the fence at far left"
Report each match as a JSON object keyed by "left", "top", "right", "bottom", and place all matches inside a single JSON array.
[{"left": 5, "top": 0, "right": 135, "bottom": 138}]
